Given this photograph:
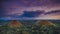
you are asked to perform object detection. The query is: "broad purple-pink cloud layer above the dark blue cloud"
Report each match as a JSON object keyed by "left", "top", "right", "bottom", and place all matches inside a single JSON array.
[{"left": 0, "top": 0, "right": 60, "bottom": 15}]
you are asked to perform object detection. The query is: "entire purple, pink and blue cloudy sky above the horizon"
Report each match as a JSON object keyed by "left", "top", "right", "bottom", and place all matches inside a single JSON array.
[{"left": 0, "top": 0, "right": 60, "bottom": 20}]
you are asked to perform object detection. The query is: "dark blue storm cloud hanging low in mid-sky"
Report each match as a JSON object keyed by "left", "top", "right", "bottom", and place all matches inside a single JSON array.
[{"left": 21, "top": 10, "right": 44, "bottom": 17}]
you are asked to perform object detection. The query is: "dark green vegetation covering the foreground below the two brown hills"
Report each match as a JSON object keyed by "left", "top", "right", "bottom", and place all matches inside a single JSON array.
[{"left": 0, "top": 20, "right": 60, "bottom": 34}]
